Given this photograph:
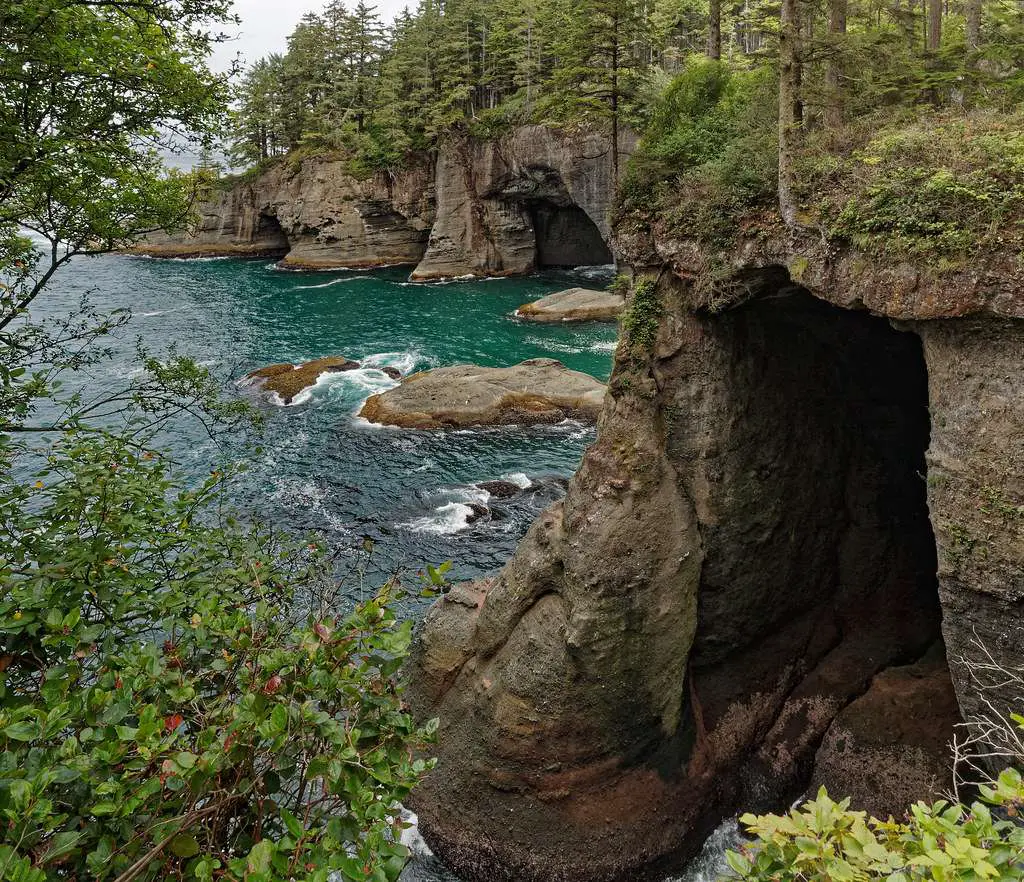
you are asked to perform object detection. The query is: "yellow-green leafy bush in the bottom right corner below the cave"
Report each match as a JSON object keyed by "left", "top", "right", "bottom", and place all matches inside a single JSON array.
[{"left": 728, "top": 753, "right": 1024, "bottom": 882}]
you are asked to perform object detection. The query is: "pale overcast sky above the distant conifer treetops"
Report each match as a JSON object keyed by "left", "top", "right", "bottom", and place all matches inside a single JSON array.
[{"left": 212, "top": 0, "right": 416, "bottom": 71}]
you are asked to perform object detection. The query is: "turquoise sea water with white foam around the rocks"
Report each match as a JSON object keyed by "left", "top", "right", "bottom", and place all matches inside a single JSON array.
[{"left": 35, "top": 255, "right": 616, "bottom": 602}]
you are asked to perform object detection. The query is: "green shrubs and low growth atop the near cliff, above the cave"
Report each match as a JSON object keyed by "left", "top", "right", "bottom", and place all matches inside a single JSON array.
[{"left": 616, "top": 60, "right": 1024, "bottom": 272}]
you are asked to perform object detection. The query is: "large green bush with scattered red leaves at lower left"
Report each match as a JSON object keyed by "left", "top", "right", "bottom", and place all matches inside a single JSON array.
[{"left": 0, "top": 430, "right": 430, "bottom": 882}]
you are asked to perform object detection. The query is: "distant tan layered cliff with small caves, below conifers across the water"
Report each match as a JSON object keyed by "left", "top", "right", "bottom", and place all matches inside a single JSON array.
[{"left": 135, "top": 126, "right": 618, "bottom": 280}]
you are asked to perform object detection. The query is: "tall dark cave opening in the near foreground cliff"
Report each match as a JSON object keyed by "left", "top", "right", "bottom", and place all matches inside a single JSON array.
[{"left": 694, "top": 285, "right": 940, "bottom": 663}]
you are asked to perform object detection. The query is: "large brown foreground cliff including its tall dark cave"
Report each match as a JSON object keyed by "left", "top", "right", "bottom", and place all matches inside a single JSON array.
[{"left": 411, "top": 218, "right": 1024, "bottom": 882}]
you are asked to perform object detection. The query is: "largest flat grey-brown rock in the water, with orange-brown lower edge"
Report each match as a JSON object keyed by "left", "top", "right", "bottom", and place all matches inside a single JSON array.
[{"left": 359, "top": 359, "right": 605, "bottom": 429}]
